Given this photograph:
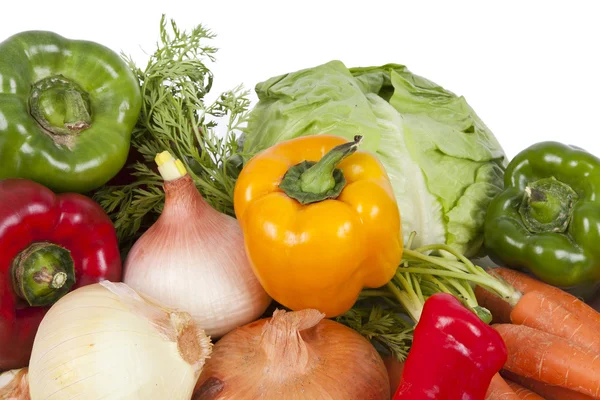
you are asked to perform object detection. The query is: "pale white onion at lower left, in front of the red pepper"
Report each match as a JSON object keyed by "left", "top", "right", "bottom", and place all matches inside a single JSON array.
[{"left": 29, "top": 281, "right": 212, "bottom": 400}]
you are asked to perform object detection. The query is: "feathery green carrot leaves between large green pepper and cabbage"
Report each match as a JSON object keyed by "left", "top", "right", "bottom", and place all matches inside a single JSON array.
[{"left": 94, "top": 15, "right": 250, "bottom": 251}]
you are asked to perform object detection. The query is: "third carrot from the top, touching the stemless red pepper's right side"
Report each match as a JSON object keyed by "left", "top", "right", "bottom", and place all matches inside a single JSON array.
[{"left": 493, "top": 321, "right": 600, "bottom": 399}]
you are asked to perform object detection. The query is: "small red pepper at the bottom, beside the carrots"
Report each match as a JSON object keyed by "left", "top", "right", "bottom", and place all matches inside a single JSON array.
[{"left": 393, "top": 293, "right": 508, "bottom": 400}]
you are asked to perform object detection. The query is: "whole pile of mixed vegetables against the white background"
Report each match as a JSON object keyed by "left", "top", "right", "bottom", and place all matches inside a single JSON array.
[{"left": 0, "top": 16, "right": 600, "bottom": 400}]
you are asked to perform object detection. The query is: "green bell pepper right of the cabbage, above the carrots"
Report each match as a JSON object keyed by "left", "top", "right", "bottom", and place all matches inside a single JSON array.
[{"left": 484, "top": 142, "right": 600, "bottom": 288}]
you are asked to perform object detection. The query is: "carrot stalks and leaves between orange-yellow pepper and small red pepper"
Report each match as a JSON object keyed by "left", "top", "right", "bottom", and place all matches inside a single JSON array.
[{"left": 337, "top": 232, "right": 521, "bottom": 361}]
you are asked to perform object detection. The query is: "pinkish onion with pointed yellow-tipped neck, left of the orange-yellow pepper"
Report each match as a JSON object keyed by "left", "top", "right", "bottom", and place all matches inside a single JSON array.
[{"left": 123, "top": 175, "right": 271, "bottom": 338}]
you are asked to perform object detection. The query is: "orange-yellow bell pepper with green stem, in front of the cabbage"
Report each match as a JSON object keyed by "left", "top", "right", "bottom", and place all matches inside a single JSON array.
[{"left": 234, "top": 135, "right": 403, "bottom": 317}]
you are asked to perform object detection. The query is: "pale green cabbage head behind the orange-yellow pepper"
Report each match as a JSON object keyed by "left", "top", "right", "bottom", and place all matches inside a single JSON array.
[{"left": 243, "top": 61, "right": 507, "bottom": 256}]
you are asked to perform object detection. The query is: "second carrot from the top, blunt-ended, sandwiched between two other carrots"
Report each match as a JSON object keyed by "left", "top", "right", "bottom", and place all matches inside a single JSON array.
[{"left": 510, "top": 292, "right": 600, "bottom": 354}]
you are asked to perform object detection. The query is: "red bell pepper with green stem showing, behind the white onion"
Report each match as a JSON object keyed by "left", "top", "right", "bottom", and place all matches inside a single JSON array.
[{"left": 0, "top": 179, "right": 121, "bottom": 370}]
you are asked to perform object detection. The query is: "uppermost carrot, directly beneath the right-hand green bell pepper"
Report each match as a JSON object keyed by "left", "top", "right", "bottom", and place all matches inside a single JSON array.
[{"left": 489, "top": 268, "right": 600, "bottom": 332}]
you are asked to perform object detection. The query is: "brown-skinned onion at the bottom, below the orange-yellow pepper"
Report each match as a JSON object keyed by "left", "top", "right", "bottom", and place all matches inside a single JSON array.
[{"left": 193, "top": 310, "right": 390, "bottom": 400}]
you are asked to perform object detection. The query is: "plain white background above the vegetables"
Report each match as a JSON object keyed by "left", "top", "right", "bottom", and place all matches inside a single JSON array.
[{"left": 0, "top": 0, "right": 600, "bottom": 158}]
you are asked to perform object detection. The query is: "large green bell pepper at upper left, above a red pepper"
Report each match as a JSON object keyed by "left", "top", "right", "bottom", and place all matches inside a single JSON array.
[{"left": 0, "top": 31, "right": 141, "bottom": 193}]
